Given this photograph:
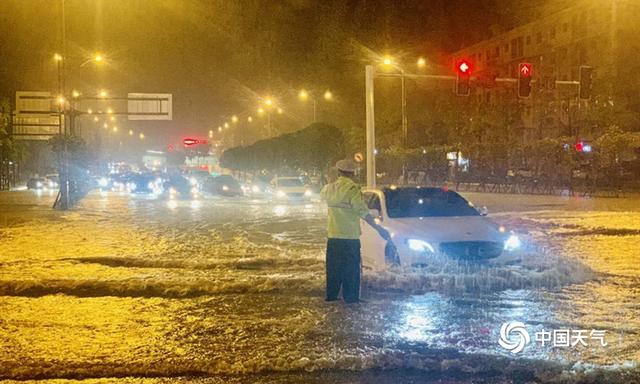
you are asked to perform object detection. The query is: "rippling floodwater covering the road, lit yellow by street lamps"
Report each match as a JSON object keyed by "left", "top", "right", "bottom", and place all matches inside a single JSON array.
[{"left": 0, "top": 191, "right": 640, "bottom": 383}]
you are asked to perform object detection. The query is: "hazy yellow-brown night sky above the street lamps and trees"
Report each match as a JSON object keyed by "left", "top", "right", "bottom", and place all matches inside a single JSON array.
[{"left": 0, "top": 0, "right": 559, "bottom": 148}]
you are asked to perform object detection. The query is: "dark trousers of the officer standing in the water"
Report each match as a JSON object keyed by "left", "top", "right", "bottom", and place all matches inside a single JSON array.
[{"left": 326, "top": 238, "right": 360, "bottom": 303}]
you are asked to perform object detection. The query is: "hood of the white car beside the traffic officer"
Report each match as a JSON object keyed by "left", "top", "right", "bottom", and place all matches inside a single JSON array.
[{"left": 383, "top": 216, "right": 504, "bottom": 243}]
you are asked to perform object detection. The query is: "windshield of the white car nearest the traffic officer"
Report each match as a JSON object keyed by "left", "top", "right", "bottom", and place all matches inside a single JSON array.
[{"left": 384, "top": 188, "right": 480, "bottom": 218}]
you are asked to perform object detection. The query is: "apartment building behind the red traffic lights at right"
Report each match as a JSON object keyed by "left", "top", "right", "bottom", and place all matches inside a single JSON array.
[{"left": 452, "top": 0, "right": 640, "bottom": 140}]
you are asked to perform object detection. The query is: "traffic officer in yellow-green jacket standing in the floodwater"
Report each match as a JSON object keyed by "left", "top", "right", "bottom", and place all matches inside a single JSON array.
[{"left": 320, "top": 160, "right": 389, "bottom": 303}]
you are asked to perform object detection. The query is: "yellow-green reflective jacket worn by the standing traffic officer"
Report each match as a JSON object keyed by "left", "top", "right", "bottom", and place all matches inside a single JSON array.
[{"left": 320, "top": 176, "right": 369, "bottom": 239}]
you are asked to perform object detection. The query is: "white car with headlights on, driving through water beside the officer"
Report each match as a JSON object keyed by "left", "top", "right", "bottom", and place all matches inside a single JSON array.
[{"left": 360, "top": 187, "right": 520, "bottom": 269}]
